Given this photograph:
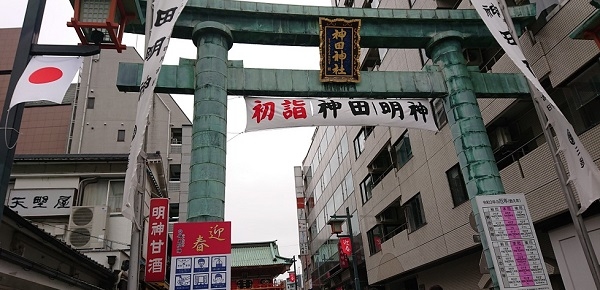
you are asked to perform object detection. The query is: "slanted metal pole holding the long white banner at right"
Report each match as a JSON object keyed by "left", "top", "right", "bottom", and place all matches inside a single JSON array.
[{"left": 498, "top": 0, "right": 600, "bottom": 289}]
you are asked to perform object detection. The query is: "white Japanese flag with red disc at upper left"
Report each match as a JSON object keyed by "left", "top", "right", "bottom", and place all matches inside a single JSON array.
[{"left": 9, "top": 56, "right": 83, "bottom": 108}]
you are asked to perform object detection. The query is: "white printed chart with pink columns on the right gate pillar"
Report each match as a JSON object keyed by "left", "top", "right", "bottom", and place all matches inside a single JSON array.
[{"left": 476, "top": 194, "right": 552, "bottom": 290}]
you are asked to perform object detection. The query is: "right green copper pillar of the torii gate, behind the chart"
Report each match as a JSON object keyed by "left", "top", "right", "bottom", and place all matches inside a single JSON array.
[{"left": 427, "top": 31, "right": 505, "bottom": 289}]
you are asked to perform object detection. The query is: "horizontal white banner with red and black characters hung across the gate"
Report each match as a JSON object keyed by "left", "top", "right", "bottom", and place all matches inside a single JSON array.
[{"left": 245, "top": 97, "right": 438, "bottom": 132}]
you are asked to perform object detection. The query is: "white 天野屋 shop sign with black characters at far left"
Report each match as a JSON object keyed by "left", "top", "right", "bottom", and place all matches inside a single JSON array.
[{"left": 6, "top": 188, "right": 75, "bottom": 217}]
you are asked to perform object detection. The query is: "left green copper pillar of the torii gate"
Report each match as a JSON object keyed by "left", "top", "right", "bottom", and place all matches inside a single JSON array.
[{"left": 187, "top": 21, "right": 233, "bottom": 222}]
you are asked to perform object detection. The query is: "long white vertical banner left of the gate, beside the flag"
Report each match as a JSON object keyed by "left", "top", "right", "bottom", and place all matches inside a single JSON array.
[{"left": 121, "top": 0, "right": 187, "bottom": 220}]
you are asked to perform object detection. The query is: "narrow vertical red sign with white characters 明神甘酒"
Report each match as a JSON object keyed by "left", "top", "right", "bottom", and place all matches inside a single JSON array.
[{"left": 145, "top": 198, "right": 169, "bottom": 282}]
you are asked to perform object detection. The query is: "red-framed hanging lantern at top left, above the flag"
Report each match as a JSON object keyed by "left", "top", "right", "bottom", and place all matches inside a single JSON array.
[{"left": 67, "top": 0, "right": 136, "bottom": 52}]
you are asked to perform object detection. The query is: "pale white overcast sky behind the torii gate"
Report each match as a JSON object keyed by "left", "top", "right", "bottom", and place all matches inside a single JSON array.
[{"left": 0, "top": 0, "right": 331, "bottom": 272}]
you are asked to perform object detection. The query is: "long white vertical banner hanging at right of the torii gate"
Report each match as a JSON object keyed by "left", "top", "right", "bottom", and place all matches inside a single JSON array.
[{"left": 471, "top": 0, "right": 600, "bottom": 214}]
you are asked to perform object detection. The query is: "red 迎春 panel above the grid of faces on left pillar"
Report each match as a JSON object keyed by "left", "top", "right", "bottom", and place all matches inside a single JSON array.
[{"left": 171, "top": 222, "right": 231, "bottom": 257}]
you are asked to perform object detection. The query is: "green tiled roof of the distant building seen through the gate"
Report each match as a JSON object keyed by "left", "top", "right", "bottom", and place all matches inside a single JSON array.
[{"left": 231, "top": 241, "right": 292, "bottom": 267}]
